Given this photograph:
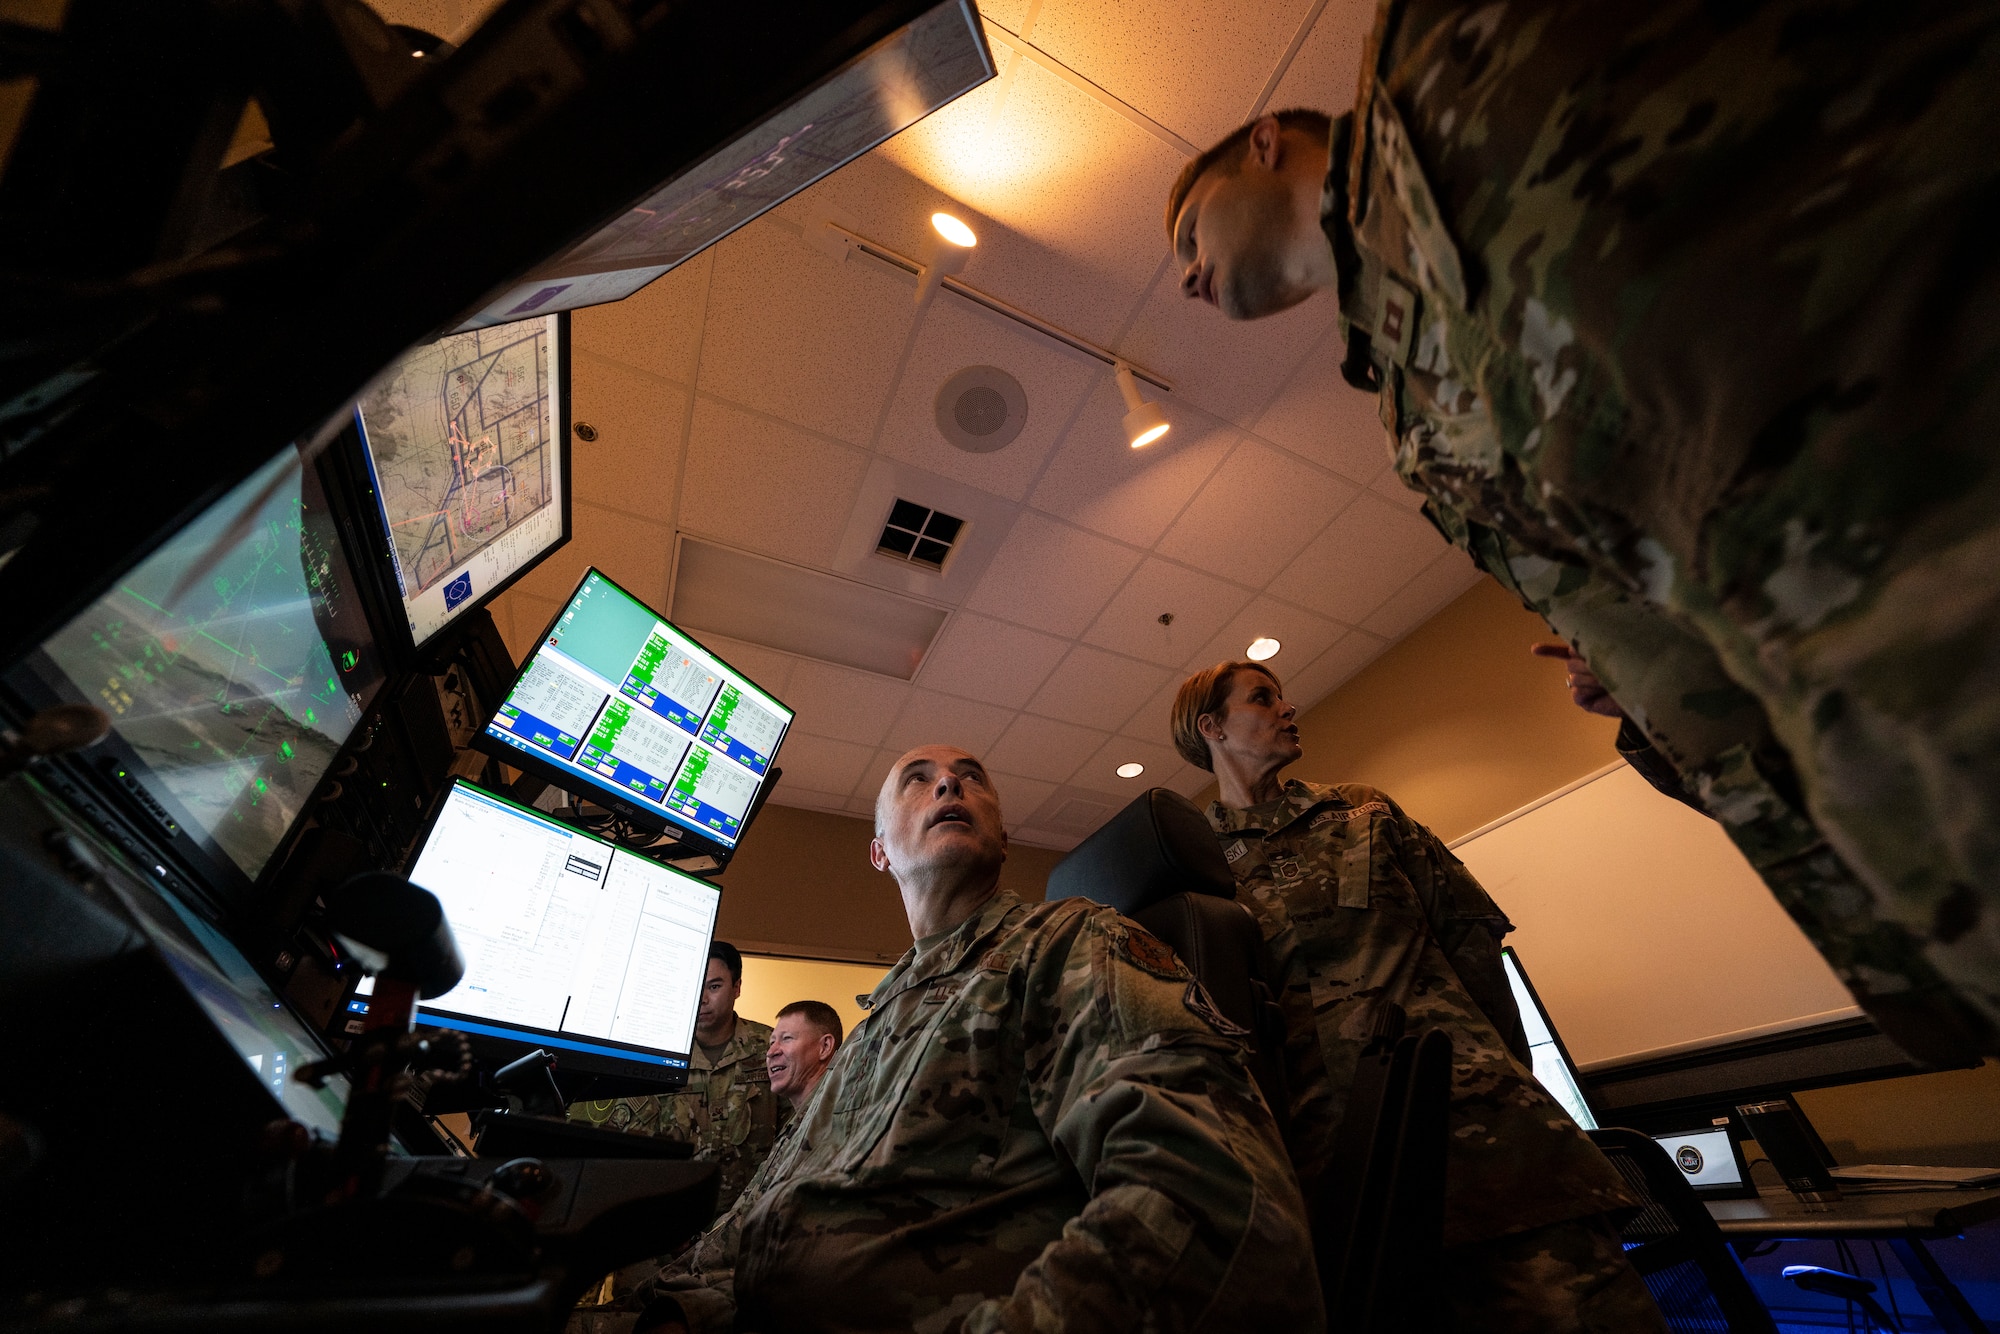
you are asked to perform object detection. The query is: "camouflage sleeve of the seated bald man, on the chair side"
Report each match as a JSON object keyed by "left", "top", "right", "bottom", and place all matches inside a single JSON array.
[{"left": 962, "top": 912, "right": 1324, "bottom": 1334}]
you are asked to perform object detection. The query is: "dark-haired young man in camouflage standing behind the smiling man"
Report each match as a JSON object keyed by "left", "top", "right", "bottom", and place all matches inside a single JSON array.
[{"left": 570, "top": 940, "right": 792, "bottom": 1212}]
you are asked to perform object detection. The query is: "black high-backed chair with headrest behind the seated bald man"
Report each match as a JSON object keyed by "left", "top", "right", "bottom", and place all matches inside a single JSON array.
[{"left": 1048, "top": 788, "right": 1290, "bottom": 1130}]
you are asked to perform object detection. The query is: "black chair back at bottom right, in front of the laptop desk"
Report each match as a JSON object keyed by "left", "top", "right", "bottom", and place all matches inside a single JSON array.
[{"left": 1590, "top": 1128, "right": 1778, "bottom": 1334}]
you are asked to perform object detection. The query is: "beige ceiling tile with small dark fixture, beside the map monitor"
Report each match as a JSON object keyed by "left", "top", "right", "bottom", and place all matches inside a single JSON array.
[{"left": 570, "top": 352, "right": 688, "bottom": 524}]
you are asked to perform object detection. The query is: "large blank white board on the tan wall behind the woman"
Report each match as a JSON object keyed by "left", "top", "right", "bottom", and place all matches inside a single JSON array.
[{"left": 1454, "top": 764, "right": 1860, "bottom": 1066}]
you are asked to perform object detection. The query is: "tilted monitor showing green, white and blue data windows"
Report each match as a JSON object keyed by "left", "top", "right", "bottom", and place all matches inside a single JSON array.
[{"left": 480, "top": 570, "right": 792, "bottom": 854}]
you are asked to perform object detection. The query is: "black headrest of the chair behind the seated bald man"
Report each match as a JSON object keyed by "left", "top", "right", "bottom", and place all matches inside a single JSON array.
[{"left": 1048, "top": 788, "right": 1236, "bottom": 916}]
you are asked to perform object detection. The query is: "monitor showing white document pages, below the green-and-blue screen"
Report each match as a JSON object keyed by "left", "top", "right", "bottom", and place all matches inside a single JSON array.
[{"left": 410, "top": 780, "right": 722, "bottom": 1084}]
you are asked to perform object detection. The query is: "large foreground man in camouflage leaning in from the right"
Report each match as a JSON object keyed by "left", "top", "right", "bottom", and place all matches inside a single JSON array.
[{"left": 1168, "top": 0, "right": 2000, "bottom": 1060}]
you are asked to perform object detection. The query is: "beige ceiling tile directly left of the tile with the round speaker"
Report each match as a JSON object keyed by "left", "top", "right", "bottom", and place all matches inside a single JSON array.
[{"left": 700, "top": 220, "right": 916, "bottom": 446}]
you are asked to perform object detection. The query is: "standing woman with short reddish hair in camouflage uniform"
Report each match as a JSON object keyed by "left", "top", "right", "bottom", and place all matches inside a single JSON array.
[{"left": 1172, "top": 662, "right": 1666, "bottom": 1334}]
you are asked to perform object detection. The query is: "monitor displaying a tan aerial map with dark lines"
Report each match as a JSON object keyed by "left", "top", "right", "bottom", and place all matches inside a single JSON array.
[{"left": 354, "top": 314, "right": 570, "bottom": 646}]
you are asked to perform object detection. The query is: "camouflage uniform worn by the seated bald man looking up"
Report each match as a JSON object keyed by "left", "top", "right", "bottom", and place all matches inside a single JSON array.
[{"left": 654, "top": 892, "right": 1324, "bottom": 1334}]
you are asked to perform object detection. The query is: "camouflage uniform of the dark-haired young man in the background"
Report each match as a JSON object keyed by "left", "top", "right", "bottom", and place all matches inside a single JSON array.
[{"left": 570, "top": 1014, "right": 792, "bottom": 1212}]
